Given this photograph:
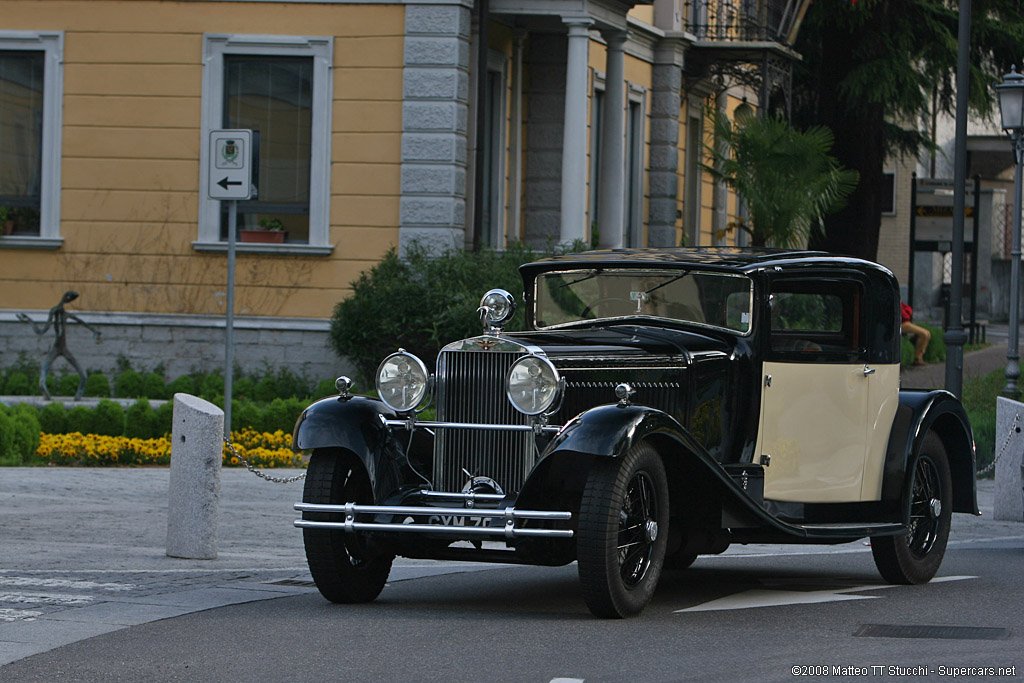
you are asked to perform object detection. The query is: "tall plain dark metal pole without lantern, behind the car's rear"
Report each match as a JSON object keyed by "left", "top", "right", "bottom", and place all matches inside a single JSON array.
[{"left": 942, "top": 0, "right": 971, "bottom": 398}]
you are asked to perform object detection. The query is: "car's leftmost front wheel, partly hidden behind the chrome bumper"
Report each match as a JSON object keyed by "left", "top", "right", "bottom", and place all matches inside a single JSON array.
[{"left": 302, "top": 451, "right": 394, "bottom": 602}]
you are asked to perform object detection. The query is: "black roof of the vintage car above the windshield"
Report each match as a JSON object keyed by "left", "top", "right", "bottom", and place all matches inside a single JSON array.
[{"left": 520, "top": 247, "right": 891, "bottom": 276}]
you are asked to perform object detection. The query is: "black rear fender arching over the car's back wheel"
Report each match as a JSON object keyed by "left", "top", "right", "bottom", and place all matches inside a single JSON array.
[{"left": 882, "top": 389, "right": 981, "bottom": 523}]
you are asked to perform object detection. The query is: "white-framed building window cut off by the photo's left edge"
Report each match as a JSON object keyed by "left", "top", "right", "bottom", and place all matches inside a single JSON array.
[{"left": 0, "top": 31, "right": 63, "bottom": 248}]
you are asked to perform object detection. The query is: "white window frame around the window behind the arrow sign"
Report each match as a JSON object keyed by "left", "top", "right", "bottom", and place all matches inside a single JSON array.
[{"left": 193, "top": 34, "right": 334, "bottom": 254}]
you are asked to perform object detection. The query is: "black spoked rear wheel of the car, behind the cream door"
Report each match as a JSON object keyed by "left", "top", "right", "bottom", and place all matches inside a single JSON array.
[{"left": 871, "top": 432, "right": 952, "bottom": 584}]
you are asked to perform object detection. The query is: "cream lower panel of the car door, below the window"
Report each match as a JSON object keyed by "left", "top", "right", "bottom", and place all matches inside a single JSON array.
[{"left": 757, "top": 362, "right": 870, "bottom": 503}]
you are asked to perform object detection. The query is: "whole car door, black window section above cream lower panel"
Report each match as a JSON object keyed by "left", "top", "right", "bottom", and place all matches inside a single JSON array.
[{"left": 756, "top": 273, "right": 880, "bottom": 503}]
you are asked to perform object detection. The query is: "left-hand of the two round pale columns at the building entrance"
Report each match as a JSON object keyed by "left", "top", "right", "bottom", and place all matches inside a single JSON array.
[{"left": 559, "top": 17, "right": 593, "bottom": 244}]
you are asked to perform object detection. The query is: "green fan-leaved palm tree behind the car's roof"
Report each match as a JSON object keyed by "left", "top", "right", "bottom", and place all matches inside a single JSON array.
[{"left": 705, "top": 111, "right": 859, "bottom": 247}]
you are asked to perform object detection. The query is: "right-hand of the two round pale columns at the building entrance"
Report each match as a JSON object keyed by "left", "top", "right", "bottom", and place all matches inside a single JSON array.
[{"left": 597, "top": 31, "right": 627, "bottom": 249}]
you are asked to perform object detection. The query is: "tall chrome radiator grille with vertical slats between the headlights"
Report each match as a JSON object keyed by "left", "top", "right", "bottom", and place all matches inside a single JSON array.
[{"left": 433, "top": 350, "right": 536, "bottom": 493}]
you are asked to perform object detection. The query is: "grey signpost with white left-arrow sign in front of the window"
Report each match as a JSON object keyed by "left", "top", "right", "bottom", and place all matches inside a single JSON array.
[{"left": 207, "top": 130, "right": 259, "bottom": 436}]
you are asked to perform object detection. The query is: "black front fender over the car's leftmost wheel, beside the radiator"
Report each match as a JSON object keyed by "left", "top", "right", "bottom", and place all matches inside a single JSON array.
[{"left": 292, "top": 396, "right": 419, "bottom": 502}]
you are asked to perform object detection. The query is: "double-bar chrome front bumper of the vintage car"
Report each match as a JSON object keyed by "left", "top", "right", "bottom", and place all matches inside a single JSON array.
[{"left": 295, "top": 503, "right": 572, "bottom": 540}]
